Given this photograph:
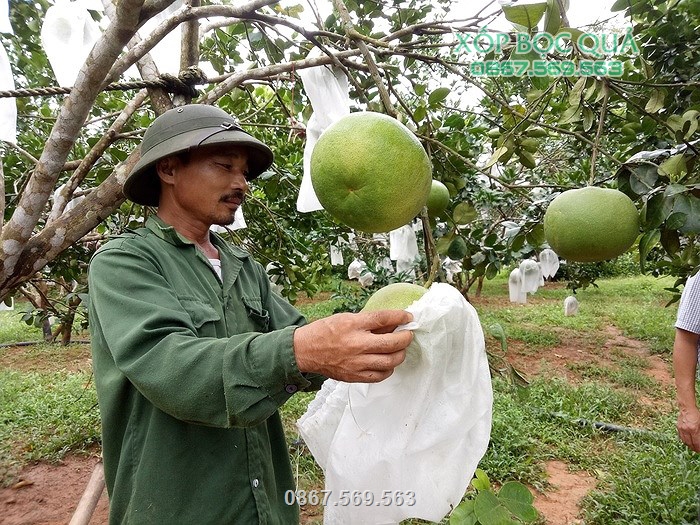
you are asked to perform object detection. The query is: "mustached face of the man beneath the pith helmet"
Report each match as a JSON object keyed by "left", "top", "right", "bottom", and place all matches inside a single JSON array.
[{"left": 158, "top": 145, "right": 248, "bottom": 227}]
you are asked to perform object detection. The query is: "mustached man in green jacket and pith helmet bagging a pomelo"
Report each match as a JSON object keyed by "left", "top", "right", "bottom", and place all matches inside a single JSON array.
[{"left": 89, "top": 105, "right": 412, "bottom": 525}]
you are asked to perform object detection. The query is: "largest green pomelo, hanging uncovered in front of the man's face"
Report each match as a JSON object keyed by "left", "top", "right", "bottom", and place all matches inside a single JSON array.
[{"left": 311, "top": 112, "right": 432, "bottom": 233}]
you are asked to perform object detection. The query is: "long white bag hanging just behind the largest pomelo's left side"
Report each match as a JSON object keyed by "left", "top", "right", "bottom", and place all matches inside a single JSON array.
[{"left": 297, "top": 48, "right": 350, "bottom": 213}]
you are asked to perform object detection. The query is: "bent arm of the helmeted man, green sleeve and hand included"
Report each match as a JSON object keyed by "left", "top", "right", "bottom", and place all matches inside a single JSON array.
[{"left": 89, "top": 244, "right": 412, "bottom": 427}]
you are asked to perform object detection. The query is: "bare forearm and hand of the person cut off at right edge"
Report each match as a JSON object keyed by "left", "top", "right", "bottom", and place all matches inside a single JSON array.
[{"left": 673, "top": 328, "right": 700, "bottom": 452}]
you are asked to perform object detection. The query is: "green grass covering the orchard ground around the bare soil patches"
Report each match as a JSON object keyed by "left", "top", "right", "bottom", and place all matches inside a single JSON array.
[{"left": 0, "top": 276, "right": 700, "bottom": 525}]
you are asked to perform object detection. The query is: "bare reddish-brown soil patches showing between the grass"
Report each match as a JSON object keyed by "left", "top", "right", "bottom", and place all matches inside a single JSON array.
[{"left": 0, "top": 308, "right": 673, "bottom": 525}]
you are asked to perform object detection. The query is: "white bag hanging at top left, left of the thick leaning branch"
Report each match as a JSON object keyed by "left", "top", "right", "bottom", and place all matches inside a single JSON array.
[{"left": 41, "top": 0, "right": 100, "bottom": 87}]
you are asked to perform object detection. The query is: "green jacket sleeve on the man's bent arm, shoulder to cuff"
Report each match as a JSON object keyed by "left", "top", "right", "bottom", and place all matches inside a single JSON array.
[{"left": 89, "top": 247, "right": 312, "bottom": 427}]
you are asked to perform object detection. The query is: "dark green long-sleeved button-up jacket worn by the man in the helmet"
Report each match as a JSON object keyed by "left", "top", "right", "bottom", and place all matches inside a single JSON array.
[{"left": 89, "top": 218, "right": 323, "bottom": 525}]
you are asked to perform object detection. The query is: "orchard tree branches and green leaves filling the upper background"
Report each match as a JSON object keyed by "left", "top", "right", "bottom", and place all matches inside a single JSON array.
[{"left": 0, "top": 0, "right": 700, "bottom": 316}]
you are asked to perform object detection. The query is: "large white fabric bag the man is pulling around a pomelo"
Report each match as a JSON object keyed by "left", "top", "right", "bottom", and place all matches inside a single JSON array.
[{"left": 297, "top": 283, "right": 493, "bottom": 525}]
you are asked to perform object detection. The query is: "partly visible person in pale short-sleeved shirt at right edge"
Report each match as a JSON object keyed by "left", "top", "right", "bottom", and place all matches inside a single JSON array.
[{"left": 673, "top": 273, "right": 700, "bottom": 452}]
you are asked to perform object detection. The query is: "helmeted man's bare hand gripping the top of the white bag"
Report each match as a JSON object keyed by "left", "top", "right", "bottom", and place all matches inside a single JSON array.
[{"left": 294, "top": 310, "right": 413, "bottom": 383}]
